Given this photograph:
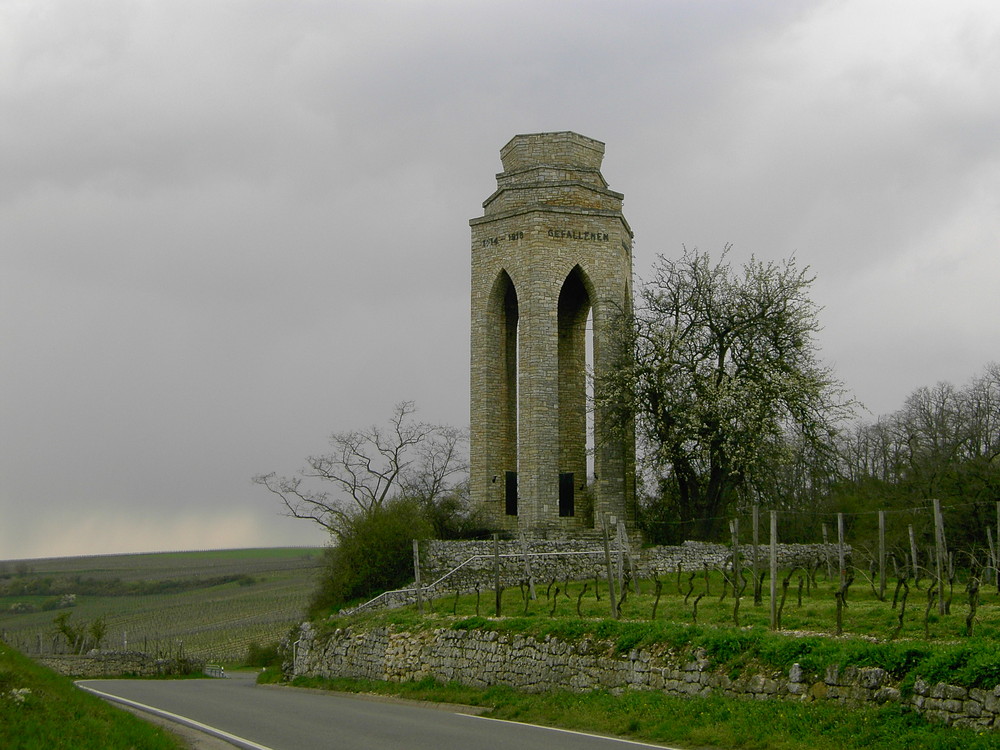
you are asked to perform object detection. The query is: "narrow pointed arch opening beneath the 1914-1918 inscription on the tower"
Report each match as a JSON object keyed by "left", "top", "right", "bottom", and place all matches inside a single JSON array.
[{"left": 492, "top": 271, "right": 519, "bottom": 516}]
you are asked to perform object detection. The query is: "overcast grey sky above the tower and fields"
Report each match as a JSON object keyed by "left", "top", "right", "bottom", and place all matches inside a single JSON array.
[{"left": 0, "top": 0, "right": 1000, "bottom": 559}]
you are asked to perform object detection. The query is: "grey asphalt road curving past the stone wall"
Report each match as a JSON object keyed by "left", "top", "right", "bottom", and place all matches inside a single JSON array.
[{"left": 78, "top": 673, "right": 672, "bottom": 750}]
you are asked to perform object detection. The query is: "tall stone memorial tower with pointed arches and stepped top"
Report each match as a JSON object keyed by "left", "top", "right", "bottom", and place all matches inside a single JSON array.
[{"left": 469, "top": 132, "right": 635, "bottom": 538}]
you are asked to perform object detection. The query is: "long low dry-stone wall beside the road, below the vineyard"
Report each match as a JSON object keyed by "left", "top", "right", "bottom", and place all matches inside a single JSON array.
[{"left": 285, "top": 623, "right": 1000, "bottom": 727}]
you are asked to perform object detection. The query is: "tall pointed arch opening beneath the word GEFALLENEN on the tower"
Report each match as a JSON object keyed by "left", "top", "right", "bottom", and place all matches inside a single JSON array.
[{"left": 558, "top": 266, "right": 593, "bottom": 517}]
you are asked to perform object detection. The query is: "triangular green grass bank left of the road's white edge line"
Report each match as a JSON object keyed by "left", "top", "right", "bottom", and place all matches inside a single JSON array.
[{"left": 0, "top": 643, "right": 184, "bottom": 750}]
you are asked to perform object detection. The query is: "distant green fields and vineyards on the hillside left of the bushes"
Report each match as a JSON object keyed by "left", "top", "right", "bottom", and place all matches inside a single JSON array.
[{"left": 0, "top": 548, "right": 322, "bottom": 663}]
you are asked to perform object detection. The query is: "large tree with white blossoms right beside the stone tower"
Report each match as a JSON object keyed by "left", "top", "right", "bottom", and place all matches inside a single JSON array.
[{"left": 596, "top": 247, "right": 852, "bottom": 539}]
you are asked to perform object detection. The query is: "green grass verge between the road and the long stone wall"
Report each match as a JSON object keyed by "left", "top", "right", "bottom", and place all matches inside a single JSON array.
[{"left": 284, "top": 678, "right": 1000, "bottom": 750}]
